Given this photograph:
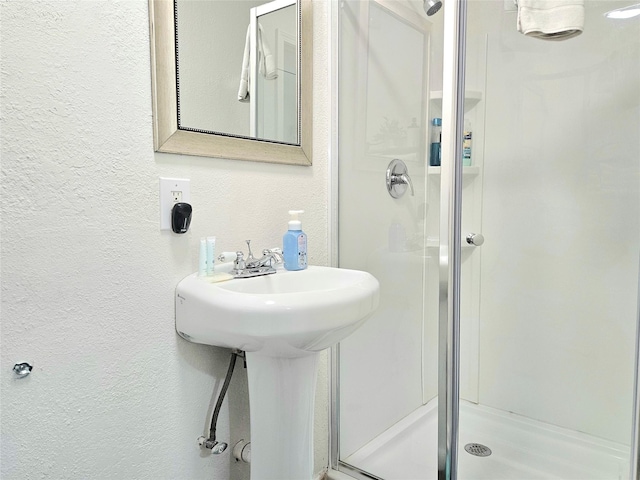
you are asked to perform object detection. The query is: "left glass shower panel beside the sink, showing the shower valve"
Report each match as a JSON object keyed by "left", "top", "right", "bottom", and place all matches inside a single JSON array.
[{"left": 336, "top": 0, "right": 437, "bottom": 478}]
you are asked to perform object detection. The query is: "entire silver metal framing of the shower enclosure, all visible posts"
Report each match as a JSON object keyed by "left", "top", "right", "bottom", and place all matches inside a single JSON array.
[{"left": 329, "top": 0, "right": 640, "bottom": 480}]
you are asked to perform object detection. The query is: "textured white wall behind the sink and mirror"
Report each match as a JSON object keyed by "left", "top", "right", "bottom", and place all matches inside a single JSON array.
[{"left": 0, "top": 0, "right": 329, "bottom": 479}]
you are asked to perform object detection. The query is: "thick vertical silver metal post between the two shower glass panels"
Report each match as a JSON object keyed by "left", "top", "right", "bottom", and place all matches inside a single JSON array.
[{"left": 438, "top": 0, "right": 467, "bottom": 474}]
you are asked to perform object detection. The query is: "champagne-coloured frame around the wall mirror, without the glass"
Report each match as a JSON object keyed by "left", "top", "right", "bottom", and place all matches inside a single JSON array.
[{"left": 149, "top": 0, "right": 313, "bottom": 166}]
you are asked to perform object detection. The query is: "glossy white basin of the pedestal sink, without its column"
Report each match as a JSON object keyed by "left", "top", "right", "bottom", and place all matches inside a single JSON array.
[{"left": 176, "top": 266, "right": 379, "bottom": 356}]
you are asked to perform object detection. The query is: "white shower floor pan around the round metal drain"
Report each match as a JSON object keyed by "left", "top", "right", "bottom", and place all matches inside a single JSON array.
[{"left": 344, "top": 401, "right": 629, "bottom": 480}]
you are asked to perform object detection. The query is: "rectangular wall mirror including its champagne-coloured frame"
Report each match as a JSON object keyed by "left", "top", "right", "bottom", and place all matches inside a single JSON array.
[{"left": 149, "top": 0, "right": 313, "bottom": 165}]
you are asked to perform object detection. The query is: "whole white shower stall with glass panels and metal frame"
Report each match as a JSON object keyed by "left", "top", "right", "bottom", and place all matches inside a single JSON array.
[{"left": 330, "top": 0, "right": 640, "bottom": 480}]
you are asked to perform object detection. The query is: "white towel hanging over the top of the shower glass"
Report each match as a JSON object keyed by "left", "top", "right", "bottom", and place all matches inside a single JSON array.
[{"left": 517, "top": 0, "right": 584, "bottom": 40}]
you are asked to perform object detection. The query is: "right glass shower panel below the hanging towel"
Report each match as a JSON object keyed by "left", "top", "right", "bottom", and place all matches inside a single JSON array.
[{"left": 458, "top": 0, "right": 640, "bottom": 480}]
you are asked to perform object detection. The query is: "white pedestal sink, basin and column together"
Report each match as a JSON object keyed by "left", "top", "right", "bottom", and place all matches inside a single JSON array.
[{"left": 176, "top": 266, "right": 379, "bottom": 480}]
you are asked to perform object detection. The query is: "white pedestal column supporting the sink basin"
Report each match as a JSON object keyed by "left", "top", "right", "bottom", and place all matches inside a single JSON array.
[{"left": 246, "top": 352, "right": 318, "bottom": 480}]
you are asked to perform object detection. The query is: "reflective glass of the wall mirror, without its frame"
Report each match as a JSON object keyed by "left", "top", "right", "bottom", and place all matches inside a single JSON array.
[{"left": 175, "top": 0, "right": 300, "bottom": 145}]
